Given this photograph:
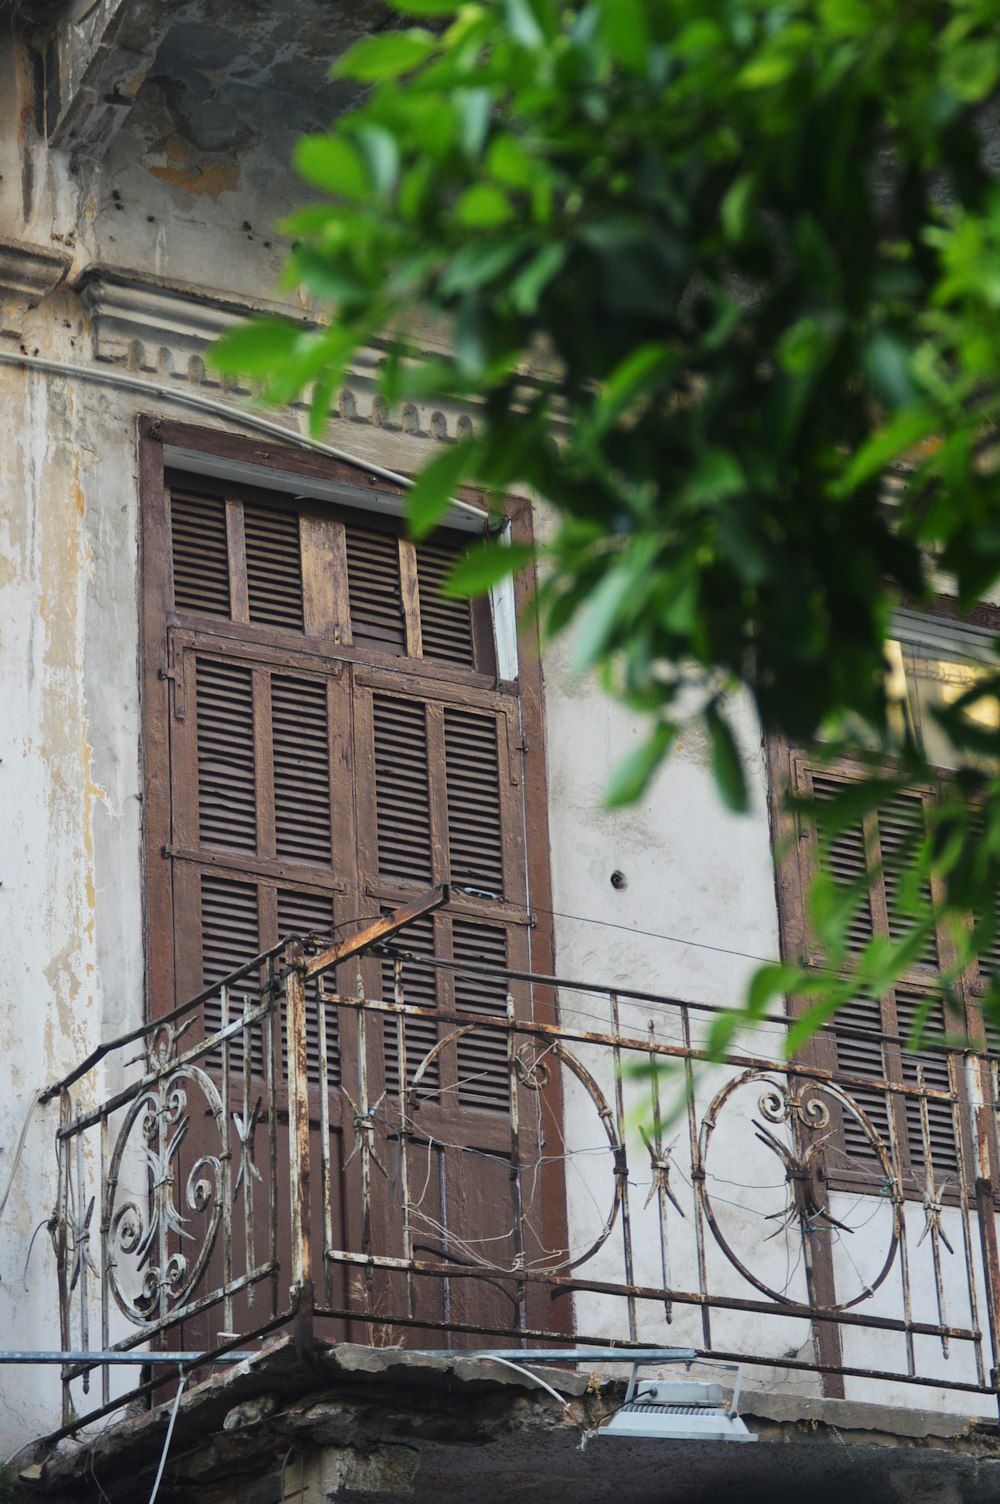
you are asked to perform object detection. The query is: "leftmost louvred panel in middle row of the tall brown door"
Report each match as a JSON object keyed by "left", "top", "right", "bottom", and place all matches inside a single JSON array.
[{"left": 195, "top": 657, "right": 257, "bottom": 851}]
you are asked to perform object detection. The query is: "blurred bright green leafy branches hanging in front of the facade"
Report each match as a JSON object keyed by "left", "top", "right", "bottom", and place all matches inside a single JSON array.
[{"left": 217, "top": 0, "right": 1000, "bottom": 1040}]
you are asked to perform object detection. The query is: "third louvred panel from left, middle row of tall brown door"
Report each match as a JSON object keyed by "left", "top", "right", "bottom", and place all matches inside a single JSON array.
[{"left": 373, "top": 695, "right": 432, "bottom": 883}]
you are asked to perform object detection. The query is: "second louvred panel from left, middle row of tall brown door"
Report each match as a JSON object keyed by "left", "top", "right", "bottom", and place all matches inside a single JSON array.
[{"left": 271, "top": 674, "right": 331, "bottom": 866}]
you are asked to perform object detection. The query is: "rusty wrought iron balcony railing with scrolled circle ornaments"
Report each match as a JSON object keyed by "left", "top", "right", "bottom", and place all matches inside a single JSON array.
[{"left": 48, "top": 890, "right": 1000, "bottom": 1427}]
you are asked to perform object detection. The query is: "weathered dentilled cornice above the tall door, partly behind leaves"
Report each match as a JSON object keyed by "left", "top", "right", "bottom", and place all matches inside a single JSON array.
[{"left": 74, "top": 265, "right": 475, "bottom": 444}]
